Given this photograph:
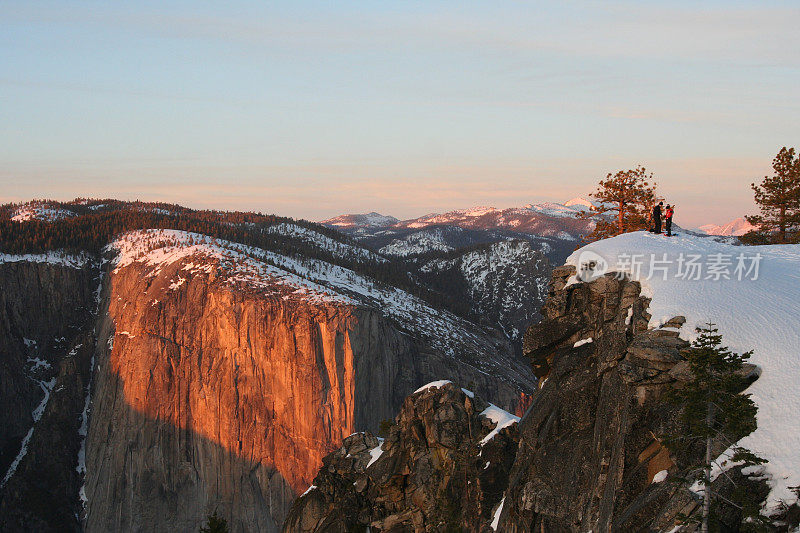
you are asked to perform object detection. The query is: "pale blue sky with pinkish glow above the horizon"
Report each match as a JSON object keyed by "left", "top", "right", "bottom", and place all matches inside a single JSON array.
[{"left": 0, "top": 0, "right": 800, "bottom": 227}]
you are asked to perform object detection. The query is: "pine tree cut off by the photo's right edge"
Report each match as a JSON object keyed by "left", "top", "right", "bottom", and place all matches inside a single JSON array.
[{"left": 746, "top": 146, "right": 800, "bottom": 243}]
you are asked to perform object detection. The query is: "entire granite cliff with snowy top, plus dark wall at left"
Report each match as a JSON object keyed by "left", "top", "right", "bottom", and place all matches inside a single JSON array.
[{"left": 0, "top": 230, "right": 535, "bottom": 532}]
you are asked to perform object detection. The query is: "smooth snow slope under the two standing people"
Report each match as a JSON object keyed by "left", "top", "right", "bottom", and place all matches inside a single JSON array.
[{"left": 567, "top": 232, "right": 800, "bottom": 509}]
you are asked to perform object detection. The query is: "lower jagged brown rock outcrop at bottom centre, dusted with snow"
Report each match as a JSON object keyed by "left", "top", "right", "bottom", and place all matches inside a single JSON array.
[{"left": 284, "top": 383, "right": 518, "bottom": 533}]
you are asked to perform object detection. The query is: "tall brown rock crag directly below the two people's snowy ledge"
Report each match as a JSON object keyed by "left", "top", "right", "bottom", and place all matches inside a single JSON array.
[{"left": 498, "top": 266, "right": 760, "bottom": 533}]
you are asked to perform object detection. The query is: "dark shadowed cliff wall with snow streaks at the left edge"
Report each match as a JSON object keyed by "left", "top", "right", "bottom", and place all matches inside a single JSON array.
[{"left": 0, "top": 256, "right": 99, "bottom": 531}]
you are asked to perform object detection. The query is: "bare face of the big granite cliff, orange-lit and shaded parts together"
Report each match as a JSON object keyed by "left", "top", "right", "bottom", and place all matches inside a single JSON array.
[{"left": 85, "top": 238, "right": 533, "bottom": 532}]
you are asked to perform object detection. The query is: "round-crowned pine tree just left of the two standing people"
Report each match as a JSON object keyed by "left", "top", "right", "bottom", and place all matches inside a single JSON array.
[{"left": 578, "top": 166, "right": 656, "bottom": 242}]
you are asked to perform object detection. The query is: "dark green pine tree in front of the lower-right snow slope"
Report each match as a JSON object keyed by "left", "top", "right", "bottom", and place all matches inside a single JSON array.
[{"left": 666, "top": 324, "right": 766, "bottom": 533}]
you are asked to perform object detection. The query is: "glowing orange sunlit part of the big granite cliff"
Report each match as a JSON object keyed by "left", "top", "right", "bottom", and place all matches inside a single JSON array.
[{"left": 104, "top": 261, "right": 354, "bottom": 492}]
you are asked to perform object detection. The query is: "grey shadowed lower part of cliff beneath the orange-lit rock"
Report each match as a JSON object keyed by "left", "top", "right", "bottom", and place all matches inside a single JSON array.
[{"left": 84, "top": 366, "right": 295, "bottom": 533}]
